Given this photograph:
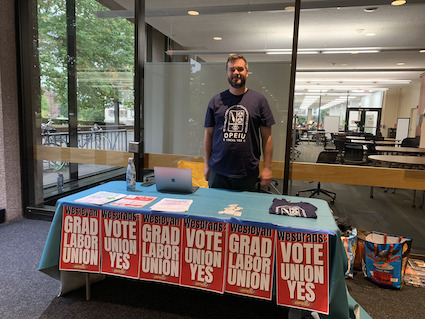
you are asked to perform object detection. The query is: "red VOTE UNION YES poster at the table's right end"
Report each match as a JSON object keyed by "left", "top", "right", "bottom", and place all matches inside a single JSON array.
[{"left": 276, "top": 231, "right": 329, "bottom": 314}]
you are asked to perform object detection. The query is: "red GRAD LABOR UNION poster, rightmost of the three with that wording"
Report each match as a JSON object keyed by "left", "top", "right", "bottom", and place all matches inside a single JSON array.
[{"left": 225, "top": 224, "right": 275, "bottom": 300}]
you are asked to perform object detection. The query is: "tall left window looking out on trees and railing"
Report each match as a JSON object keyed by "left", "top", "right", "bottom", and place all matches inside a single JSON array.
[{"left": 23, "top": 0, "right": 134, "bottom": 205}]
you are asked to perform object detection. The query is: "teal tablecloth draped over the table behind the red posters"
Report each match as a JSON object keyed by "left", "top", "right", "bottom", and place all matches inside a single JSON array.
[{"left": 39, "top": 181, "right": 370, "bottom": 319}]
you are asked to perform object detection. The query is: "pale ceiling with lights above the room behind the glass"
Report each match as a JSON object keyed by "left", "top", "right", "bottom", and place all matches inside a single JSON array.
[{"left": 100, "top": 0, "right": 425, "bottom": 109}]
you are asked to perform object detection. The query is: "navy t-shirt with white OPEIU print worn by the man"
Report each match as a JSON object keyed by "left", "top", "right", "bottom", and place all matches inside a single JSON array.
[{"left": 204, "top": 90, "right": 275, "bottom": 178}]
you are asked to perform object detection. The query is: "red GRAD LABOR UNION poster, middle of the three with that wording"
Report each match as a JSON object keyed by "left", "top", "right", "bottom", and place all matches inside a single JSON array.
[{"left": 140, "top": 215, "right": 182, "bottom": 284}]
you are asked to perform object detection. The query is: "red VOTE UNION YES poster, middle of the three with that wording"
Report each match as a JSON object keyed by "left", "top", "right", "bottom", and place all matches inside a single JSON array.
[{"left": 180, "top": 218, "right": 228, "bottom": 293}]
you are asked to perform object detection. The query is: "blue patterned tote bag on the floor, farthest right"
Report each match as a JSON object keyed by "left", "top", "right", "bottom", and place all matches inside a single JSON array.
[{"left": 363, "top": 232, "right": 412, "bottom": 288}]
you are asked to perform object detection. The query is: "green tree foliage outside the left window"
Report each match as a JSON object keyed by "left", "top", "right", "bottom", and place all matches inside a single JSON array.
[{"left": 38, "top": 0, "right": 134, "bottom": 122}]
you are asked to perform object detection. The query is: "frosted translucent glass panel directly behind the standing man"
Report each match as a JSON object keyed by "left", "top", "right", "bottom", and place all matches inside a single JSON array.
[{"left": 145, "top": 60, "right": 290, "bottom": 161}]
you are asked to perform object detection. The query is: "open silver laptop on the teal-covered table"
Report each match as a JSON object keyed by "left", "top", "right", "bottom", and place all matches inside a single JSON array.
[{"left": 153, "top": 166, "right": 199, "bottom": 194}]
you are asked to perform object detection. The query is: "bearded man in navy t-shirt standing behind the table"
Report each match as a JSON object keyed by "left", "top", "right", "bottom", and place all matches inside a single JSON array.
[{"left": 204, "top": 54, "right": 275, "bottom": 191}]
